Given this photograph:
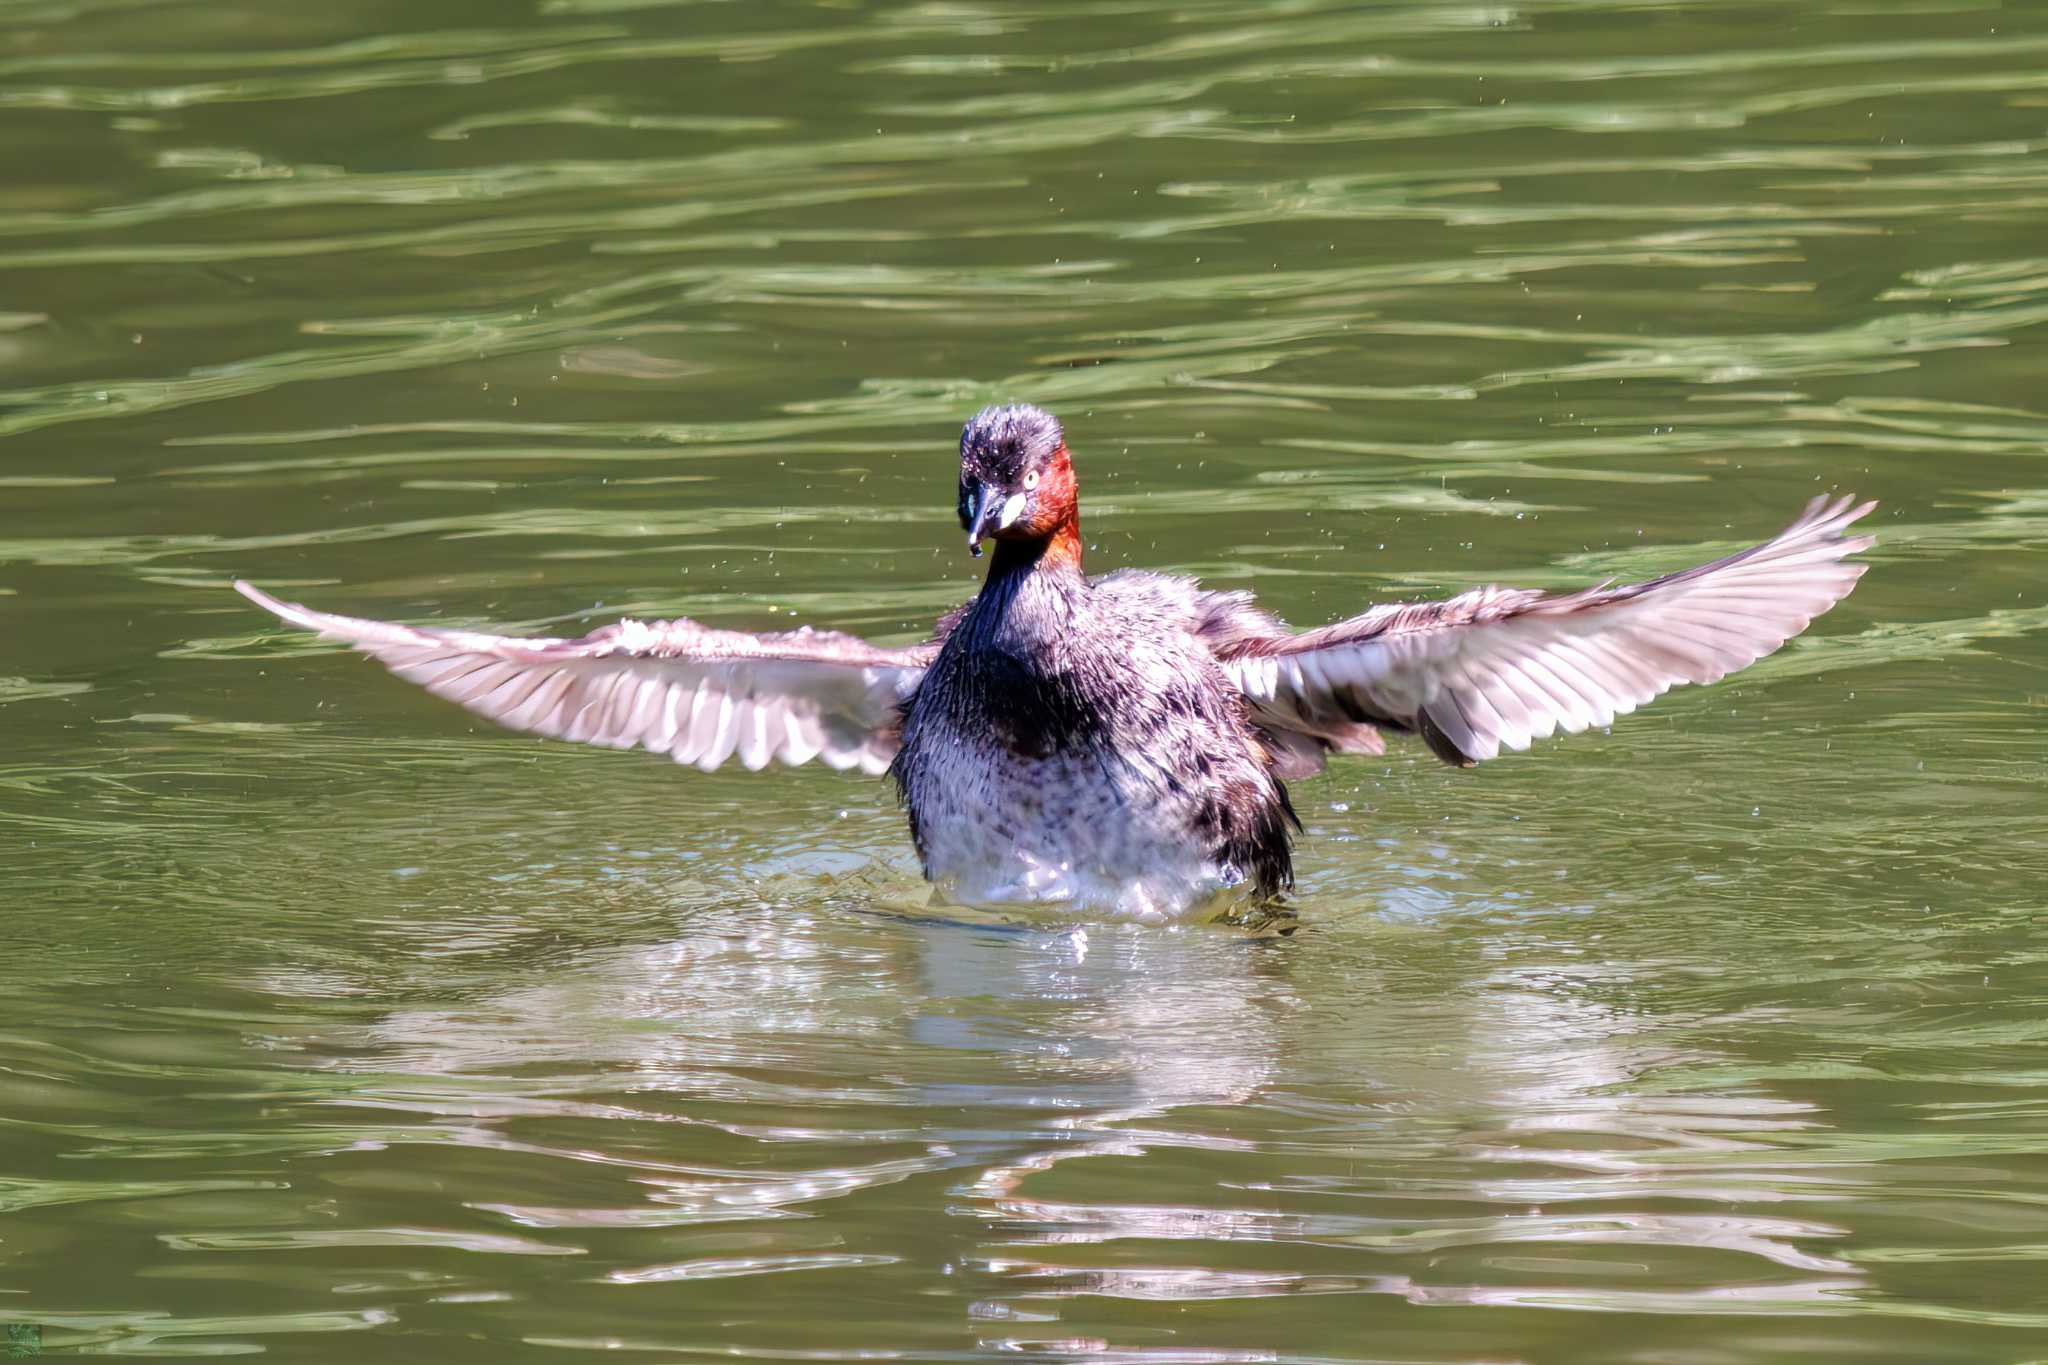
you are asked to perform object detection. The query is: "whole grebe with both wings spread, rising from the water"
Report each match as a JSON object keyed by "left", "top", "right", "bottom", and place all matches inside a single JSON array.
[{"left": 236, "top": 403, "right": 1876, "bottom": 923}]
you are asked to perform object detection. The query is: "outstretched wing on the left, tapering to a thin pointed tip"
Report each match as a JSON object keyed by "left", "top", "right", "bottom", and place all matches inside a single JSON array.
[{"left": 236, "top": 583, "right": 932, "bottom": 774}]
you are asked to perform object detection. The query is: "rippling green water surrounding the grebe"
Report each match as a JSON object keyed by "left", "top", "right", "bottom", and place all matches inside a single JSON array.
[{"left": 0, "top": 0, "right": 2048, "bottom": 1365}]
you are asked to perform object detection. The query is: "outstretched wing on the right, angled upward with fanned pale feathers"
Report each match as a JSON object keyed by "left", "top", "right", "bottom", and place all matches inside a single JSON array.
[{"left": 1217, "top": 497, "right": 1876, "bottom": 767}]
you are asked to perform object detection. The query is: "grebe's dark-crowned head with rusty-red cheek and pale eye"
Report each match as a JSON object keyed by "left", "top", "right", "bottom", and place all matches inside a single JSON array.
[{"left": 961, "top": 403, "right": 1077, "bottom": 555}]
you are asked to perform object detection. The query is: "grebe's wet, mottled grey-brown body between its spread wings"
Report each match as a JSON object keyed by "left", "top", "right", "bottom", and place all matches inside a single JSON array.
[{"left": 891, "top": 551, "right": 1294, "bottom": 919}]
